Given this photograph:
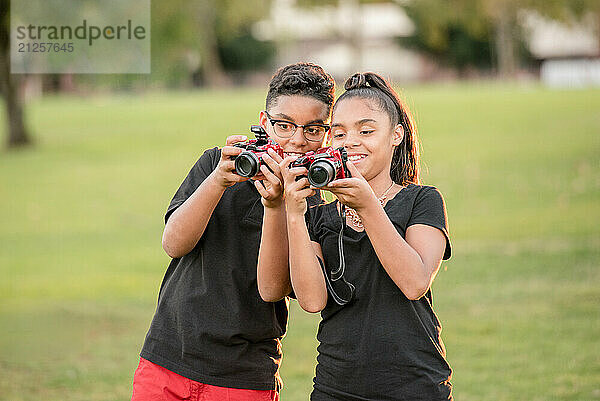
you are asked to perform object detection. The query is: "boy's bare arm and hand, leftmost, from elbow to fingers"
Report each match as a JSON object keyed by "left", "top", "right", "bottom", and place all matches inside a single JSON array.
[{"left": 162, "top": 135, "right": 247, "bottom": 258}]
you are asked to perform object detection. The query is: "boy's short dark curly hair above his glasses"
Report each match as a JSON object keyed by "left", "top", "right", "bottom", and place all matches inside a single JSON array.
[{"left": 266, "top": 63, "right": 335, "bottom": 114}]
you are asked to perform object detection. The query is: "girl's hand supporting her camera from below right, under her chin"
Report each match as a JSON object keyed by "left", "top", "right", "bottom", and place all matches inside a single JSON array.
[{"left": 323, "top": 162, "right": 378, "bottom": 212}]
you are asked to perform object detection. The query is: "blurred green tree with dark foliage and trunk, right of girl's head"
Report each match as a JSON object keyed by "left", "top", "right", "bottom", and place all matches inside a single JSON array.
[{"left": 405, "top": 0, "right": 600, "bottom": 77}]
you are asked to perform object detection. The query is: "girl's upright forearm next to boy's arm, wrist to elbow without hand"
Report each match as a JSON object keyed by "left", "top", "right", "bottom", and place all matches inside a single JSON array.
[{"left": 287, "top": 215, "right": 327, "bottom": 313}]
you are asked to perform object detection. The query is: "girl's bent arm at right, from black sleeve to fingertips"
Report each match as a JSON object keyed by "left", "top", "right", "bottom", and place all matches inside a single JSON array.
[{"left": 329, "top": 163, "right": 446, "bottom": 300}]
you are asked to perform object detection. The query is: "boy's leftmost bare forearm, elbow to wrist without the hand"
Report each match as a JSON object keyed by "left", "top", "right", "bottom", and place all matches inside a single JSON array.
[{"left": 162, "top": 170, "right": 226, "bottom": 258}]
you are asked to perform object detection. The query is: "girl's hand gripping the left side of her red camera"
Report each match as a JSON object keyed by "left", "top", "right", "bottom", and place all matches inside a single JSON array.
[{"left": 279, "top": 156, "right": 315, "bottom": 216}]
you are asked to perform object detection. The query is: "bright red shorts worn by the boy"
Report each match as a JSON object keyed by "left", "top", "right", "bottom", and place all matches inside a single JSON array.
[{"left": 131, "top": 358, "right": 279, "bottom": 401}]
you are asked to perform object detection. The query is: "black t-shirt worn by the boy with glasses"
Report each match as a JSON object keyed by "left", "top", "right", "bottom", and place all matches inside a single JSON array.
[{"left": 141, "top": 148, "right": 288, "bottom": 390}]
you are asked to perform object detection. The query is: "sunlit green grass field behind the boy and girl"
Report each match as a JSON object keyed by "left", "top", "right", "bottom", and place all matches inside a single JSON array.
[{"left": 0, "top": 85, "right": 600, "bottom": 401}]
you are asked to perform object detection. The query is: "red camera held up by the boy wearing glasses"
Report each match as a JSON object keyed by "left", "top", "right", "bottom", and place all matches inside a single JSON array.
[{"left": 233, "top": 125, "right": 283, "bottom": 177}]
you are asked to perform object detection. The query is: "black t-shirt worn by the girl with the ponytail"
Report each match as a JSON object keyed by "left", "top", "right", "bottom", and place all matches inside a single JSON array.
[{"left": 309, "top": 184, "right": 452, "bottom": 401}]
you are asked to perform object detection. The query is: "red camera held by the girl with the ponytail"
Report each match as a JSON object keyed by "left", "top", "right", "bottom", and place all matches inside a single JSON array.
[{"left": 290, "top": 147, "right": 350, "bottom": 188}]
